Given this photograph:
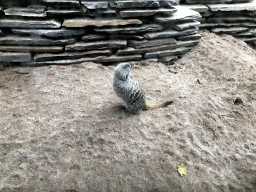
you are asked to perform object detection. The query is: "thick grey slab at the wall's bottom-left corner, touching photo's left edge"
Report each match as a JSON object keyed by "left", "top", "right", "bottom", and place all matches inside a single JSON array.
[{"left": 0, "top": 52, "right": 31, "bottom": 62}]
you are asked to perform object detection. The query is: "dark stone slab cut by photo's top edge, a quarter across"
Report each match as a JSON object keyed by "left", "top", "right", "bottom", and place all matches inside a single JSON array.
[{"left": 42, "top": 0, "right": 80, "bottom": 8}]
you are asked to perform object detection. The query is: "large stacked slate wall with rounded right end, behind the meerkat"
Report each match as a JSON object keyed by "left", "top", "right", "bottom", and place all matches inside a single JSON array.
[{"left": 0, "top": 0, "right": 201, "bottom": 66}]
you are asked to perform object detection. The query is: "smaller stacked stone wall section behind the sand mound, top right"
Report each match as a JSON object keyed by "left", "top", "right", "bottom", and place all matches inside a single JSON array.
[{"left": 182, "top": 0, "right": 256, "bottom": 44}]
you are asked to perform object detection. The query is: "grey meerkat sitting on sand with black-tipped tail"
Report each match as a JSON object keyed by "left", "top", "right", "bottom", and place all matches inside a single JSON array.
[{"left": 112, "top": 62, "right": 173, "bottom": 114}]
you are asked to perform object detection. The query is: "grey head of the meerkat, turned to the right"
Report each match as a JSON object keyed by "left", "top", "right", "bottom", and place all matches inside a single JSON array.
[{"left": 114, "top": 62, "right": 134, "bottom": 81}]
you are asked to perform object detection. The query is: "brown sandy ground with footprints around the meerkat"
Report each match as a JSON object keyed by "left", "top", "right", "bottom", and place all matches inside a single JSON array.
[{"left": 0, "top": 32, "right": 256, "bottom": 192}]
